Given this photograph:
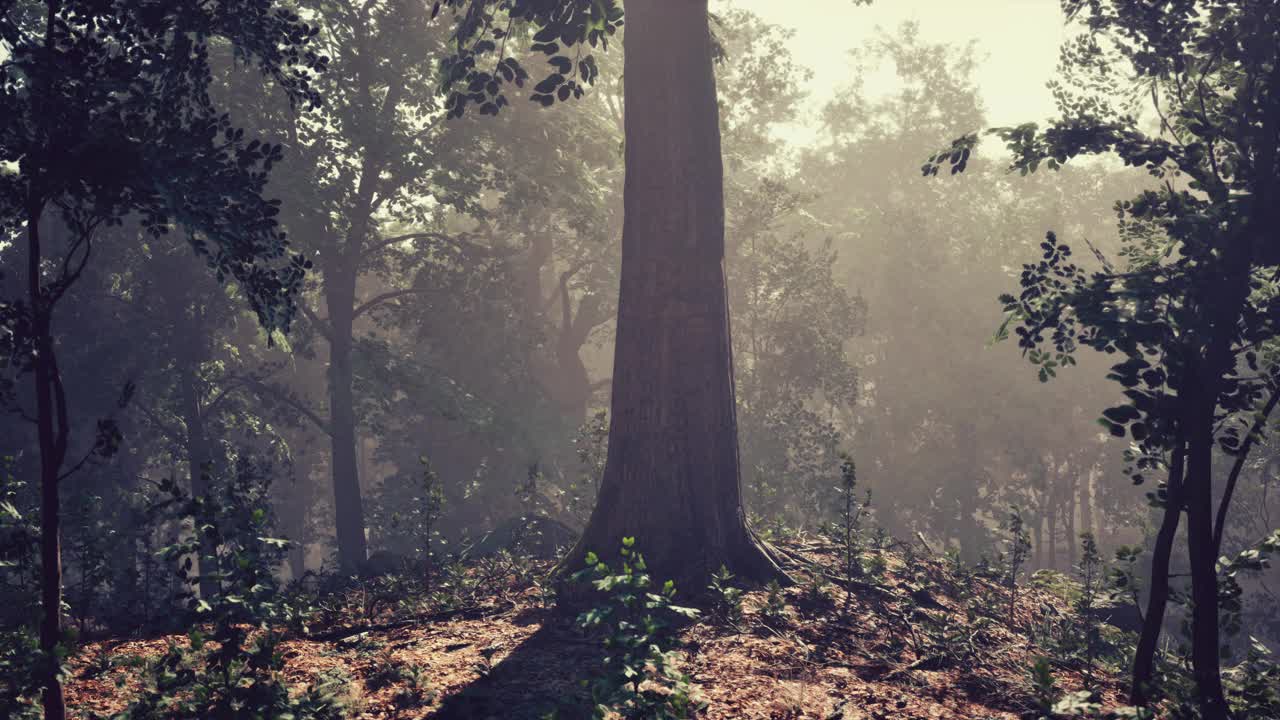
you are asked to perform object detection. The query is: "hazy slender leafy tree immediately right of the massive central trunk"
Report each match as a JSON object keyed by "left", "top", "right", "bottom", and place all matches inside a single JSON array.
[{"left": 726, "top": 190, "right": 865, "bottom": 527}]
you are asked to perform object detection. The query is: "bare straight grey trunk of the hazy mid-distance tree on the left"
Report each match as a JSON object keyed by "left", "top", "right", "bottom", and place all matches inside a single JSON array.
[{"left": 325, "top": 269, "right": 367, "bottom": 573}]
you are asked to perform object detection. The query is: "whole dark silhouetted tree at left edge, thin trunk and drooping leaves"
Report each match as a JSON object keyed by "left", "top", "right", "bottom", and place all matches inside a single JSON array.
[{"left": 0, "top": 0, "right": 324, "bottom": 720}]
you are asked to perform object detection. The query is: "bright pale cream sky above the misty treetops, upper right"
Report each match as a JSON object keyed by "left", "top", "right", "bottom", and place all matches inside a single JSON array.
[{"left": 713, "top": 0, "right": 1065, "bottom": 142}]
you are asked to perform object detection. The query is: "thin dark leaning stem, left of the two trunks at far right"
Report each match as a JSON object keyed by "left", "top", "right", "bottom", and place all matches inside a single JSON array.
[{"left": 1129, "top": 432, "right": 1185, "bottom": 705}]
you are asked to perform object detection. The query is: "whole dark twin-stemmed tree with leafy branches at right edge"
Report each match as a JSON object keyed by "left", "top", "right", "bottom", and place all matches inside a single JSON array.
[{"left": 924, "top": 0, "right": 1280, "bottom": 720}]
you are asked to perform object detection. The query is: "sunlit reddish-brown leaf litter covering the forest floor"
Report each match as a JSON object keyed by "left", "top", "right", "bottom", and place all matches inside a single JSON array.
[{"left": 67, "top": 542, "right": 1136, "bottom": 720}]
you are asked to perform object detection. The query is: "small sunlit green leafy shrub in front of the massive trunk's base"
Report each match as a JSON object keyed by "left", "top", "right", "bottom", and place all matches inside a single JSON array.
[{"left": 572, "top": 538, "right": 701, "bottom": 719}]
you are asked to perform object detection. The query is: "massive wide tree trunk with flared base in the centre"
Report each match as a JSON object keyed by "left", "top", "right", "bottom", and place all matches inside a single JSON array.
[{"left": 566, "top": 0, "right": 785, "bottom": 593}]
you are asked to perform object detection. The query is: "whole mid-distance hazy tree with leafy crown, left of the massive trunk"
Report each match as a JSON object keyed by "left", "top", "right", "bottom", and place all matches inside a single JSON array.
[{"left": 233, "top": 0, "right": 504, "bottom": 573}]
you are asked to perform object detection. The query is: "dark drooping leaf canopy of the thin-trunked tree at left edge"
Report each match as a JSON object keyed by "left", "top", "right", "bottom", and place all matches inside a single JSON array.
[{"left": 0, "top": 0, "right": 325, "bottom": 329}]
